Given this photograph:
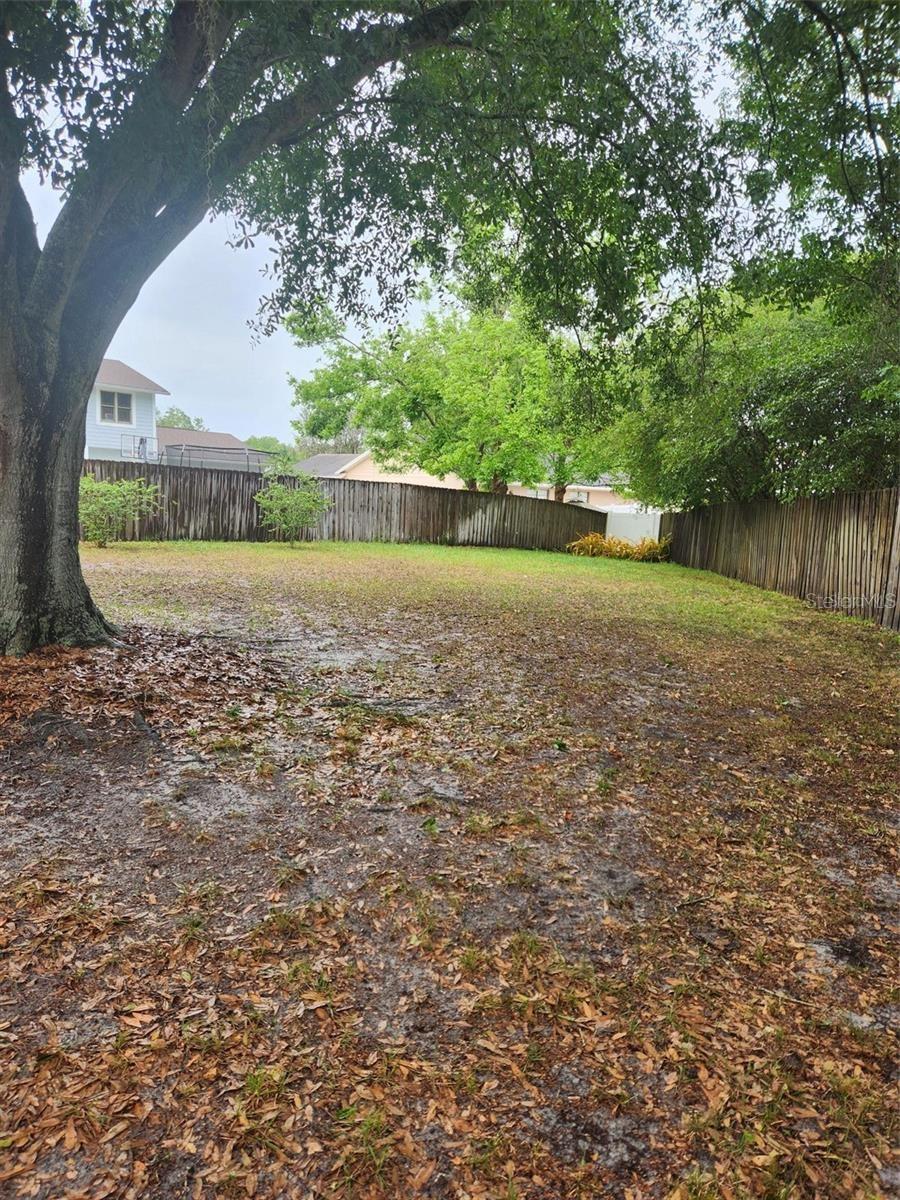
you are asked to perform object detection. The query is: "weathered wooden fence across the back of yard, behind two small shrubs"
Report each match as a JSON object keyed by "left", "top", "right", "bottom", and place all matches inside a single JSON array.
[{"left": 84, "top": 460, "right": 606, "bottom": 550}]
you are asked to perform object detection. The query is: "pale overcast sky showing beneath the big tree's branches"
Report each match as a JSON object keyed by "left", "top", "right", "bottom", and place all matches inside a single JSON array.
[{"left": 25, "top": 176, "right": 319, "bottom": 440}]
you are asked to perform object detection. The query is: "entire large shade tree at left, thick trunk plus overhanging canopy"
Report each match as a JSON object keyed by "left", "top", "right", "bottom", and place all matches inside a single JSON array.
[{"left": 0, "top": 0, "right": 720, "bottom": 653}]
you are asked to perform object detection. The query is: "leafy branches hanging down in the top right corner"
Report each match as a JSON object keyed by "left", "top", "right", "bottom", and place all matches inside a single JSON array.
[{"left": 721, "top": 0, "right": 900, "bottom": 301}]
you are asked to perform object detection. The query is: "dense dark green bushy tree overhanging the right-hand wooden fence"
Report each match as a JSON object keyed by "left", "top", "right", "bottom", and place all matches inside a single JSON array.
[{"left": 595, "top": 301, "right": 900, "bottom": 508}]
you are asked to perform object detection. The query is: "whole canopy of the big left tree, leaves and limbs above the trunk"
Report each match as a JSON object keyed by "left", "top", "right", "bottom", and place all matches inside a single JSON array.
[{"left": 0, "top": 0, "right": 724, "bottom": 357}]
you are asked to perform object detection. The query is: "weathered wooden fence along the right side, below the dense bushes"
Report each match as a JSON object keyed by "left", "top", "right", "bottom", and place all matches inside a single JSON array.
[{"left": 660, "top": 487, "right": 900, "bottom": 629}]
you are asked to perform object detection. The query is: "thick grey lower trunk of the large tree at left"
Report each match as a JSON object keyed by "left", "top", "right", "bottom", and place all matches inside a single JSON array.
[{"left": 0, "top": 371, "right": 114, "bottom": 654}]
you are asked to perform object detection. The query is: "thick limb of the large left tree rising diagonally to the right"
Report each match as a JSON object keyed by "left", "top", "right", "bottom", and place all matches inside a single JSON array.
[{"left": 26, "top": 0, "right": 480, "bottom": 348}]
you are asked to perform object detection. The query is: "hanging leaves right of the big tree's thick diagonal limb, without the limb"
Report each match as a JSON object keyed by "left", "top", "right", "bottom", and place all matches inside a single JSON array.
[{"left": 230, "top": 0, "right": 718, "bottom": 340}]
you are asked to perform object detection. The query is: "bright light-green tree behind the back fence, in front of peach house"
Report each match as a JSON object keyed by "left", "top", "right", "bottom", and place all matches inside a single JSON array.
[{"left": 288, "top": 310, "right": 609, "bottom": 498}]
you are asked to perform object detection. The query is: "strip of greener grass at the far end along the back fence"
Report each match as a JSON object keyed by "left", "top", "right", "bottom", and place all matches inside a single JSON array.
[{"left": 83, "top": 532, "right": 889, "bottom": 644}]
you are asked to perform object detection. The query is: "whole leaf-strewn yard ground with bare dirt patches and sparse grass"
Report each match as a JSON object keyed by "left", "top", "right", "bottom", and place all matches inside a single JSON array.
[{"left": 0, "top": 545, "right": 900, "bottom": 1200}]
